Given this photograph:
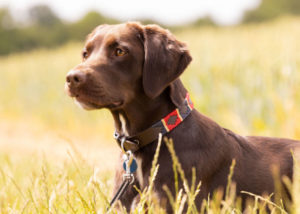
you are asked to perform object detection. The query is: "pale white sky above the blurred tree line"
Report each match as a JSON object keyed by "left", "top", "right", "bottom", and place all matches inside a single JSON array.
[{"left": 0, "top": 0, "right": 260, "bottom": 25}]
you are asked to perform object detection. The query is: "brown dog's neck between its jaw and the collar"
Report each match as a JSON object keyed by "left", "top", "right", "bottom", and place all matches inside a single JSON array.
[{"left": 111, "top": 90, "right": 176, "bottom": 136}]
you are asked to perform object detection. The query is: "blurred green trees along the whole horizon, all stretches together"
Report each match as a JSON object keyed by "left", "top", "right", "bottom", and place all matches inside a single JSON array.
[{"left": 0, "top": 0, "right": 300, "bottom": 55}]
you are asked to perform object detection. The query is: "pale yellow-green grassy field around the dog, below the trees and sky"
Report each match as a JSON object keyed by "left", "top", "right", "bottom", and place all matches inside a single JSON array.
[{"left": 0, "top": 17, "right": 300, "bottom": 213}]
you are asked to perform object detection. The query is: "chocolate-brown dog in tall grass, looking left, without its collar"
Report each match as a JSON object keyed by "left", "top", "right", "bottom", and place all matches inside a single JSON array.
[{"left": 66, "top": 23, "right": 299, "bottom": 213}]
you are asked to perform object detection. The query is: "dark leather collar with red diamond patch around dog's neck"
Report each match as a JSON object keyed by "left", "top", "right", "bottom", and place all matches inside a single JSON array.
[{"left": 114, "top": 93, "right": 194, "bottom": 152}]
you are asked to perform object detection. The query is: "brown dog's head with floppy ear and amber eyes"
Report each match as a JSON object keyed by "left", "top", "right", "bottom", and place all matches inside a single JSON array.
[{"left": 65, "top": 23, "right": 192, "bottom": 109}]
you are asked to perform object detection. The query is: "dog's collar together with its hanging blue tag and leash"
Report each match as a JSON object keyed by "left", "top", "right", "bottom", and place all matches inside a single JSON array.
[{"left": 107, "top": 93, "right": 194, "bottom": 212}]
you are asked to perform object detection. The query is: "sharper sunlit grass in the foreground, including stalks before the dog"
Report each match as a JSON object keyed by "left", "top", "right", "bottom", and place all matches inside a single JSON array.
[{"left": 0, "top": 139, "right": 300, "bottom": 214}]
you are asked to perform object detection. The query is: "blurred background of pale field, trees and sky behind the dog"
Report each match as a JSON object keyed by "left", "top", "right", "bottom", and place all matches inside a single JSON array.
[{"left": 0, "top": 0, "right": 300, "bottom": 174}]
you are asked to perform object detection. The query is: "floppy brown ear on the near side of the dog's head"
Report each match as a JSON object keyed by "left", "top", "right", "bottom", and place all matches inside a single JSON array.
[{"left": 143, "top": 25, "right": 192, "bottom": 99}]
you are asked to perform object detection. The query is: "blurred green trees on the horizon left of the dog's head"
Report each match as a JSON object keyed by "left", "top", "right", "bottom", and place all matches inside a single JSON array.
[{"left": 0, "top": 5, "right": 119, "bottom": 55}]
